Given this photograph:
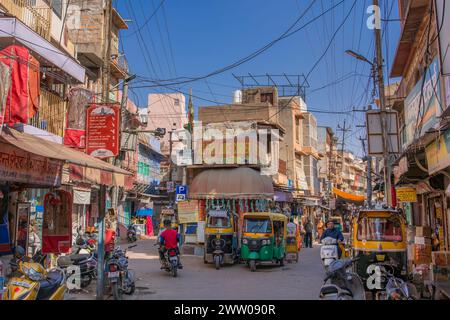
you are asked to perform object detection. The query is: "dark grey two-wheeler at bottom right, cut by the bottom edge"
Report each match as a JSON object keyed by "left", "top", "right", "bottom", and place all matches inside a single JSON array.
[{"left": 319, "top": 259, "right": 366, "bottom": 300}]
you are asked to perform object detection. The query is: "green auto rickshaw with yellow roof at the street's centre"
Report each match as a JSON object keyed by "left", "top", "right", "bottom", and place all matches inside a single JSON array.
[{"left": 241, "top": 212, "right": 288, "bottom": 272}]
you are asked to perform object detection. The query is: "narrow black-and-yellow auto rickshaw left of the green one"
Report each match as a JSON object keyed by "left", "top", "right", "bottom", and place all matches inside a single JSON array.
[{"left": 204, "top": 210, "right": 237, "bottom": 270}]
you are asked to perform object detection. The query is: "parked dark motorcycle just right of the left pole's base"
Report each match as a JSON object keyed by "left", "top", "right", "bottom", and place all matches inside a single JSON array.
[{"left": 106, "top": 245, "right": 137, "bottom": 300}]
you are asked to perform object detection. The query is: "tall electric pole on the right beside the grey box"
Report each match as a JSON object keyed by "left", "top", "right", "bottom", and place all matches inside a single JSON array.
[{"left": 373, "top": 0, "right": 392, "bottom": 207}]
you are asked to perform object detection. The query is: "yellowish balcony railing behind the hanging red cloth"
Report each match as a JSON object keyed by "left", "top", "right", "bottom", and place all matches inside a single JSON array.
[{"left": 30, "top": 88, "right": 67, "bottom": 137}]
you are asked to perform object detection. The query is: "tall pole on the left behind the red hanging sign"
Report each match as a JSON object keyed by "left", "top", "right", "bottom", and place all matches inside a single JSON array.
[{"left": 97, "top": 0, "right": 112, "bottom": 300}]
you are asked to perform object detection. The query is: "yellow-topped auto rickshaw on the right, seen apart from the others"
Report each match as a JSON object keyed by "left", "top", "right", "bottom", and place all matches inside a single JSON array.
[{"left": 351, "top": 209, "right": 407, "bottom": 290}]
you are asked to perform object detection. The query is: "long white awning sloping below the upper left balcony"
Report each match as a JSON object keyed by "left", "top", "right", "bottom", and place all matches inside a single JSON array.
[{"left": 0, "top": 17, "right": 86, "bottom": 83}]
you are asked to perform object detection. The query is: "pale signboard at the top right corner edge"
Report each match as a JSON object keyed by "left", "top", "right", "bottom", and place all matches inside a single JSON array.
[{"left": 436, "top": 0, "right": 450, "bottom": 75}]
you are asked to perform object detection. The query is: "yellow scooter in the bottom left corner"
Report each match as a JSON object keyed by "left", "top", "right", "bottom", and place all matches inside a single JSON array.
[{"left": 2, "top": 261, "right": 67, "bottom": 300}]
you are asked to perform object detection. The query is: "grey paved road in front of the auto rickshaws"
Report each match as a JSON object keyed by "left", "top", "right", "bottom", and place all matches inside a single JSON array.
[{"left": 69, "top": 240, "right": 324, "bottom": 300}]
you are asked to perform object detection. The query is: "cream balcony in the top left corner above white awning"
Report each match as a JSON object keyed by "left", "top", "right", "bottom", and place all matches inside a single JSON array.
[{"left": 0, "top": 0, "right": 52, "bottom": 41}]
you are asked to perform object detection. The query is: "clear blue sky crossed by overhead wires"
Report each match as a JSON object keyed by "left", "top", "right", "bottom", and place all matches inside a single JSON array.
[{"left": 115, "top": 0, "right": 400, "bottom": 155}]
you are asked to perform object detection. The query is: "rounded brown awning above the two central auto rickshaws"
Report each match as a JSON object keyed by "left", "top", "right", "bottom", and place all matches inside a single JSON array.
[{"left": 188, "top": 167, "right": 275, "bottom": 199}]
